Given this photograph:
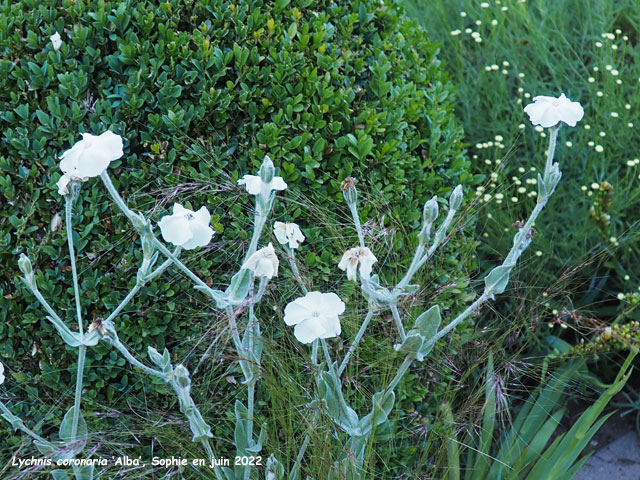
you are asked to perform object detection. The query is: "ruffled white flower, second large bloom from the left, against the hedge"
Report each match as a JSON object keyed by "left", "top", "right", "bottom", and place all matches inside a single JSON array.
[{"left": 158, "top": 203, "right": 213, "bottom": 250}]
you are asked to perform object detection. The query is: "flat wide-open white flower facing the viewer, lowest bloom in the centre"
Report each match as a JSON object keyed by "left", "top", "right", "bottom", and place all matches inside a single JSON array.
[{"left": 284, "top": 292, "right": 345, "bottom": 343}]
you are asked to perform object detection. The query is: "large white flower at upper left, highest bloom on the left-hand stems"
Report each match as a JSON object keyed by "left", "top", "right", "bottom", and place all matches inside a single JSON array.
[{"left": 60, "top": 130, "right": 124, "bottom": 180}]
